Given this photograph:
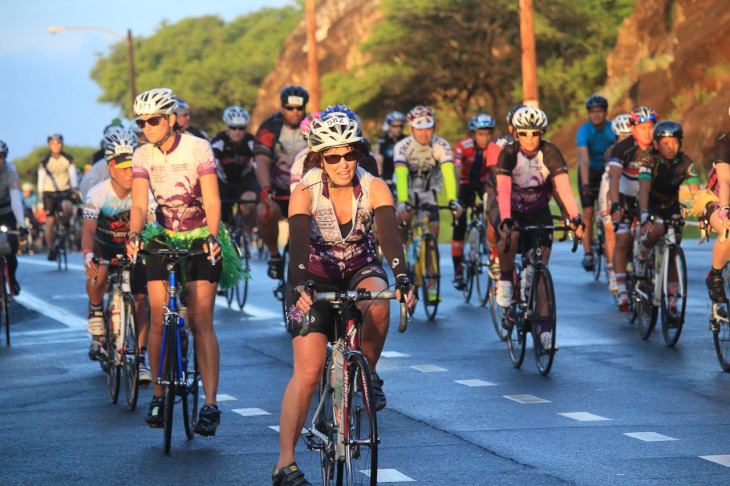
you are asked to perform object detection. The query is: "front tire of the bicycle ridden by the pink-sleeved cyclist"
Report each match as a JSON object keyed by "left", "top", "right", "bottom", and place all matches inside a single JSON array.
[{"left": 530, "top": 266, "right": 557, "bottom": 376}]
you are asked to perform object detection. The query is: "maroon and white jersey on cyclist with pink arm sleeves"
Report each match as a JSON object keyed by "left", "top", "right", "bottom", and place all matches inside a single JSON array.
[{"left": 497, "top": 140, "right": 568, "bottom": 213}]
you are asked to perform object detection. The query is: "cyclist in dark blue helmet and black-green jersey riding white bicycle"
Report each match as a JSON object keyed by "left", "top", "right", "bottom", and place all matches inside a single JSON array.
[{"left": 635, "top": 120, "right": 700, "bottom": 320}]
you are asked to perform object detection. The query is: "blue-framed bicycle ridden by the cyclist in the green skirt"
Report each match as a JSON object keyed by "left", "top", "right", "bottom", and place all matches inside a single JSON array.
[{"left": 139, "top": 248, "right": 203, "bottom": 454}]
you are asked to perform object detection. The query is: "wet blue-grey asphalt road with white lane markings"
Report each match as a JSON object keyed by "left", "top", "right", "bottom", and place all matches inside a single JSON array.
[{"left": 0, "top": 240, "right": 730, "bottom": 485}]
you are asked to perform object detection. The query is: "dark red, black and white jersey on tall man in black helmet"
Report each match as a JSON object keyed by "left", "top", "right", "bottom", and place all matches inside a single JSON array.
[{"left": 254, "top": 113, "right": 307, "bottom": 194}]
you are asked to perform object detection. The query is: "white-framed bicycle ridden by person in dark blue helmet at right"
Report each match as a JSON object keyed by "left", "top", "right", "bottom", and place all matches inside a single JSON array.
[{"left": 634, "top": 217, "right": 687, "bottom": 346}]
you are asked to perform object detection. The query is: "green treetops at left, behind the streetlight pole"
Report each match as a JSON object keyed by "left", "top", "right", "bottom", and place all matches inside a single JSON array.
[{"left": 91, "top": 5, "right": 304, "bottom": 133}]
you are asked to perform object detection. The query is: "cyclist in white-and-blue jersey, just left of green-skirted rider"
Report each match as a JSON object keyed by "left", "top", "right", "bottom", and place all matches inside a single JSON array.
[{"left": 81, "top": 139, "right": 157, "bottom": 388}]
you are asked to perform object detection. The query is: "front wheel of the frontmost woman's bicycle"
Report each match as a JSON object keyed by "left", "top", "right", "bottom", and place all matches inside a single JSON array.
[{"left": 341, "top": 354, "right": 379, "bottom": 486}]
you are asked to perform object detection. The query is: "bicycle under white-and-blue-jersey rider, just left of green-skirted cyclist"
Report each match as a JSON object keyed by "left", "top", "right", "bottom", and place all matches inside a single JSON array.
[{"left": 93, "top": 255, "right": 139, "bottom": 410}]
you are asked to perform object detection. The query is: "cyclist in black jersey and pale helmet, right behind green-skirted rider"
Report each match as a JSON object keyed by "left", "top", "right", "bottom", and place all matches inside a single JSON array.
[{"left": 210, "top": 106, "right": 259, "bottom": 235}]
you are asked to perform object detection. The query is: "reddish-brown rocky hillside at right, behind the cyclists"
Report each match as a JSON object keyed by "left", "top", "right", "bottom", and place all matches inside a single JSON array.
[{"left": 552, "top": 0, "right": 730, "bottom": 172}]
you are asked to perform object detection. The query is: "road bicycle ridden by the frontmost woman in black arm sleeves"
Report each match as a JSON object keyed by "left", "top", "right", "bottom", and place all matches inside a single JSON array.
[{"left": 300, "top": 282, "right": 408, "bottom": 486}]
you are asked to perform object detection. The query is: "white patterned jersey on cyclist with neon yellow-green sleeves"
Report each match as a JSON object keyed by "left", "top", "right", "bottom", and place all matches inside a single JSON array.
[{"left": 393, "top": 135, "right": 456, "bottom": 196}]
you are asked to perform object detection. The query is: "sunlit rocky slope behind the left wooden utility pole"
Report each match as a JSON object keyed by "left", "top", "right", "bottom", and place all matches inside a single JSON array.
[{"left": 251, "top": 0, "right": 382, "bottom": 126}]
